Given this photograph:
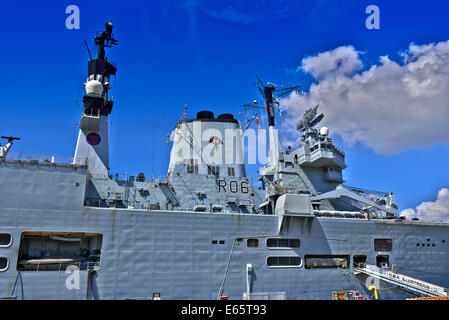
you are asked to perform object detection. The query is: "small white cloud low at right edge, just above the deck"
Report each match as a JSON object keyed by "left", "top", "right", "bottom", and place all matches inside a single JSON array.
[{"left": 401, "top": 188, "right": 449, "bottom": 222}]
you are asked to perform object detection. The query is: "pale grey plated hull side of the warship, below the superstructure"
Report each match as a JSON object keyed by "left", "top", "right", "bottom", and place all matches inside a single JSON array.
[{"left": 0, "top": 160, "right": 449, "bottom": 299}]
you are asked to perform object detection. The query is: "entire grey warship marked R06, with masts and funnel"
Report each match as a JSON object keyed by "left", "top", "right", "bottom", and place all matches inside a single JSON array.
[{"left": 0, "top": 23, "right": 449, "bottom": 300}]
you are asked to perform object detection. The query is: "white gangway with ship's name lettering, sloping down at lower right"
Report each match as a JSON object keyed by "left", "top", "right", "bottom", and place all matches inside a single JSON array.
[{"left": 354, "top": 265, "right": 449, "bottom": 297}]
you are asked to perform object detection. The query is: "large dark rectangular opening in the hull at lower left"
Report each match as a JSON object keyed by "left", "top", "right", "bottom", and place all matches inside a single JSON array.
[{"left": 17, "top": 232, "right": 103, "bottom": 271}]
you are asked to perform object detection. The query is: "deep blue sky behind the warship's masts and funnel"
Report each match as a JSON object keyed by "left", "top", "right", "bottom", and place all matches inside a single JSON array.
[{"left": 0, "top": 0, "right": 449, "bottom": 215}]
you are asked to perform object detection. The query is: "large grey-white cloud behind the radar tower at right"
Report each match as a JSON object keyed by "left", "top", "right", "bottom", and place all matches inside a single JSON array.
[{"left": 281, "top": 41, "right": 449, "bottom": 154}]
